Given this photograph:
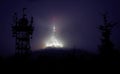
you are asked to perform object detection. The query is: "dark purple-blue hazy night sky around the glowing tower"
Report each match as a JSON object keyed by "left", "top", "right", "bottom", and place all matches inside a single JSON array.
[{"left": 0, "top": 0, "right": 120, "bottom": 55}]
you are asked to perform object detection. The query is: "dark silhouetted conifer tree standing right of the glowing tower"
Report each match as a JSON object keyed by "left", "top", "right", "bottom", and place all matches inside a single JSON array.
[{"left": 99, "top": 13, "right": 117, "bottom": 56}]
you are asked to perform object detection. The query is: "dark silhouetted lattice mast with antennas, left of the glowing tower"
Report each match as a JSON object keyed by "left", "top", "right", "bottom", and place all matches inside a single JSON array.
[{"left": 12, "top": 8, "right": 33, "bottom": 54}]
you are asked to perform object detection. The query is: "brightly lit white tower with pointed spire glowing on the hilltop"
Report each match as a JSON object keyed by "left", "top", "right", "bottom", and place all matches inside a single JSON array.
[{"left": 45, "top": 21, "right": 63, "bottom": 48}]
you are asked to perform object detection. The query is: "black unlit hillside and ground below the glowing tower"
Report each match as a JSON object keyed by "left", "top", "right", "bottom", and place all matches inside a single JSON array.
[{"left": 0, "top": 50, "right": 120, "bottom": 72}]
